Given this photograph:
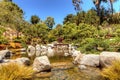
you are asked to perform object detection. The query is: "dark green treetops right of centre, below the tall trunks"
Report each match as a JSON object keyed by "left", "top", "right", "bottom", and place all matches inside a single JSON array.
[{"left": 63, "top": 10, "right": 100, "bottom": 26}]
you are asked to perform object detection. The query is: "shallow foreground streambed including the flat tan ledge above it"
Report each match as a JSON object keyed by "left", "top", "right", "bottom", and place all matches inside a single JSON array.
[{"left": 34, "top": 62, "right": 104, "bottom": 80}]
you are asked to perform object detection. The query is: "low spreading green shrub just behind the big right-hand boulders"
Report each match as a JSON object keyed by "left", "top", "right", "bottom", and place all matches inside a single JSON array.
[{"left": 80, "top": 38, "right": 109, "bottom": 53}]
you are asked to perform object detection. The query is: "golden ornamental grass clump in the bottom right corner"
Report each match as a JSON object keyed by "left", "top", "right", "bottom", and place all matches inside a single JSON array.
[{"left": 101, "top": 60, "right": 120, "bottom": 80}]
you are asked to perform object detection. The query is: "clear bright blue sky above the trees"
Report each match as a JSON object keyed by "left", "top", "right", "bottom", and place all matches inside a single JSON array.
[{"left": 13, "top": 0, "right": 120, "bottom": 24}]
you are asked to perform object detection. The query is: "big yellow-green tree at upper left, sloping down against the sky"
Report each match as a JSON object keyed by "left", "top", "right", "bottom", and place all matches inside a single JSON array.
[{"left": 0, "top": 1, "right": 24, "bottom": 37}]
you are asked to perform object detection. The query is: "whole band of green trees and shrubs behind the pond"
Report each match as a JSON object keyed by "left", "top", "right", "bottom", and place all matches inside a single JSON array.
[{"left": 0, "top": 0, "right": 120, "bottom": 53}]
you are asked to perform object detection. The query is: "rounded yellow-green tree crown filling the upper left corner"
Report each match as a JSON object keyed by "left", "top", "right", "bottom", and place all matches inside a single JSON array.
[{"left": 0, "top": 1, "right": 23, "bottom": 27}]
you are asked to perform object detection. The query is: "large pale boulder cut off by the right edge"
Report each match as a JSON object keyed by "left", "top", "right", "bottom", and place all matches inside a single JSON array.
[{"left": 100, "top": 52, "right": 120, "bottom": 68}]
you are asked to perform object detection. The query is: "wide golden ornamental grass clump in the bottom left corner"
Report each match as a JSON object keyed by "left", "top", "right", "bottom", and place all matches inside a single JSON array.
[{"left": 0, "top": 63, "right": 33, "bottom": 80}]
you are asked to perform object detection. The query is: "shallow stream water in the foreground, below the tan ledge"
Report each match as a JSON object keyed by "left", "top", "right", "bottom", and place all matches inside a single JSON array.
[{"left": 34, "top": 67, "right": 105, "bottom": 80}]
